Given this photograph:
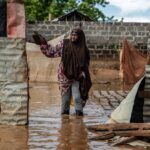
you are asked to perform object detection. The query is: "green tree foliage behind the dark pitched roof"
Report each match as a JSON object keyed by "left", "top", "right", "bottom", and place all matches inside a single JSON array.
[{"left": 24, "top": 0, "right": 108, "bottom": 21}]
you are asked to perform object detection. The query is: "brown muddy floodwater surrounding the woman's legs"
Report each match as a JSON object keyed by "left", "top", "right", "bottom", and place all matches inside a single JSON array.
[{"left": 0, "top": 82, "right": 145, "bottom": 150}]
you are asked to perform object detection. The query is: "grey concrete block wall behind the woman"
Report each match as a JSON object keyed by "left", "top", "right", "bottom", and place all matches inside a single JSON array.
[{"left": 27, "top": 21, "right": 150, "bottom": 58}]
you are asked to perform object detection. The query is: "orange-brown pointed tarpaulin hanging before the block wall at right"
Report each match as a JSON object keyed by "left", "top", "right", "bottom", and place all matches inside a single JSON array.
[{"left": 120, "top": 39, "right": 147, "bottom": 85}]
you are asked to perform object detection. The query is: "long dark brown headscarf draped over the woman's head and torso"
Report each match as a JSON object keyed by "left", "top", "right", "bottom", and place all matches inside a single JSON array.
[{"left": 62, "top": 29, "right": 90, "bottom": 80}]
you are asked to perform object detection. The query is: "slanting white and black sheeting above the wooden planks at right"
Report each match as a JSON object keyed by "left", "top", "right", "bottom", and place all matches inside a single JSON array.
[{"left": 108, "top": 65, "right": 150, "bottom": 123}]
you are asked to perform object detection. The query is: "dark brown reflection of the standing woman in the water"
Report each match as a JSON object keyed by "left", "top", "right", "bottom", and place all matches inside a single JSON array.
[{"left": 57, "top": 116, "right": 88, "bottom": 150}]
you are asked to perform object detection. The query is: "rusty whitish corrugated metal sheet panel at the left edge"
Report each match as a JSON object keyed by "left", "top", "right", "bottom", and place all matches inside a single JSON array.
[{"left": 0, "top": 38, "right": 28, "bottom": 125}]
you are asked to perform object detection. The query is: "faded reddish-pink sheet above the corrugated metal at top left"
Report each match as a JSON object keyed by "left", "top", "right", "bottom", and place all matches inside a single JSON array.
[{"left": 7, "top": 0, "right": 25, "bottom": 38}]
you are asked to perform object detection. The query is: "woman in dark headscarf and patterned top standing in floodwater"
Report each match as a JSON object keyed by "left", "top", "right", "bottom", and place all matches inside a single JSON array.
[{"left": 33, "top": 29, "right": 92, "bottom": 116}]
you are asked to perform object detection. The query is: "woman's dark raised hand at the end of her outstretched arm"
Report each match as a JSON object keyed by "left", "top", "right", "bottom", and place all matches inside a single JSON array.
[{"left": 32, "top": 31, "right": 47, "bottom": 45}]
